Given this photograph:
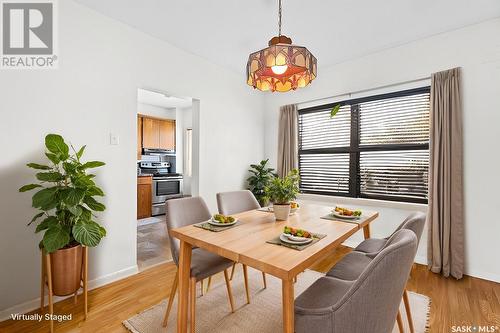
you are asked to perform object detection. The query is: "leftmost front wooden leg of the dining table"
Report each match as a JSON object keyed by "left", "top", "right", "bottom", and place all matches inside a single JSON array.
[{"left": 177, "top": 240, "right": 192, "bottom": 333}]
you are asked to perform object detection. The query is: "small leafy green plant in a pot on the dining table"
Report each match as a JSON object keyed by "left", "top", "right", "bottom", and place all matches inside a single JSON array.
[{"left": 266, "top": 169, "right": 299, "bottom": 220}]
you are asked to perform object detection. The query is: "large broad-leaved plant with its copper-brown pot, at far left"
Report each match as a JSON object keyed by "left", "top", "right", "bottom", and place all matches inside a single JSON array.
[{"left": 19, "top": 134, "right": 106, "bottom": 296}]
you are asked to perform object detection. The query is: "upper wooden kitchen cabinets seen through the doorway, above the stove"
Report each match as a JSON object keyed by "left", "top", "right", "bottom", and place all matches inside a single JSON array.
[{"left": 138, "top": 116, "right": 175, "bottom": 150}]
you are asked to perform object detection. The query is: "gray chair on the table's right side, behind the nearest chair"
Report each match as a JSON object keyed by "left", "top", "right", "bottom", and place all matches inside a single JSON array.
[{"left": 327, "top": 212, "right": 426, "bottom": 333}]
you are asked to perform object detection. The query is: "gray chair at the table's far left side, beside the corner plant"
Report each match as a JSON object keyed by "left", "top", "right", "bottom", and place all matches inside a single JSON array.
[{"left": 216, "top": 190, "right": 267, "bottom": 294}]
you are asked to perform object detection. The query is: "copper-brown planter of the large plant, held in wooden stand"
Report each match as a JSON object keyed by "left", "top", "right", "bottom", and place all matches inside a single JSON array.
[{"left": 50, "top": 245, "right": 82, "bottom": 296}]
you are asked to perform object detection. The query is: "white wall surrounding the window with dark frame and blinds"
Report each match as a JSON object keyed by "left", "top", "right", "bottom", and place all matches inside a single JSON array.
[{"left": 264, "top": 19, "right": 500, "bottom": 281}]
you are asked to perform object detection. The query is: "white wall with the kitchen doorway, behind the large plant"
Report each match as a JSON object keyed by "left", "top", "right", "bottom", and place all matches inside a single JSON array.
[{"left": 0, "top": 1, "right": 264, "bottom": 316}]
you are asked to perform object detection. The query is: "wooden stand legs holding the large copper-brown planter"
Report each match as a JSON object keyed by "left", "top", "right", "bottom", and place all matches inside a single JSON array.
[{"left": 40, "top": 246, "right": 89, "bottom": 333}]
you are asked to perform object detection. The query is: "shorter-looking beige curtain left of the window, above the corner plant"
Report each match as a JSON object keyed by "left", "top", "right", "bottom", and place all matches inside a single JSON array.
[{"left": 277, "top": 105, "right": 299, "bottom": 177}]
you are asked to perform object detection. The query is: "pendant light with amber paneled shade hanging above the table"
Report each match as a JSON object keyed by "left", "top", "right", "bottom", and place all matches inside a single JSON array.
[{"left": 247, "top": 0, "right": 317, "bottom": 92}]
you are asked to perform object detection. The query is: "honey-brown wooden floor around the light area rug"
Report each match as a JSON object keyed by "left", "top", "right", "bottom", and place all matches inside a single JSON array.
[{"left": 0, "top": 247, "right": 500, "bottom": 333}]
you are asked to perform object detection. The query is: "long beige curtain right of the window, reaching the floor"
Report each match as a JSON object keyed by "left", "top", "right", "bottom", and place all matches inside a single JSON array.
[{"left": 427, "top": 68, "right": 464, "bottom": 279}]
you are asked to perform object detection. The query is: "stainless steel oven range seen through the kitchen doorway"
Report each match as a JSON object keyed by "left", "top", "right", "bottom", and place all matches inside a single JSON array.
[{"left": 152, "top": 174, "right": 183, "bottom": 215}]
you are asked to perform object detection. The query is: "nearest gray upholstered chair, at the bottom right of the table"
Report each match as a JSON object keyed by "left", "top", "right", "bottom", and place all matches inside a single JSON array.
[{"left": 295, "top": 230, "right": 417, "bottom": 333}]
